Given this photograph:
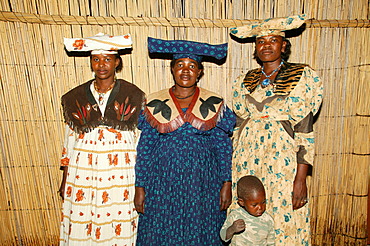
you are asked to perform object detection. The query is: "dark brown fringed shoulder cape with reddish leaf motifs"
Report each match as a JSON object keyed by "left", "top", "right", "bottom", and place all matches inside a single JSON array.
[{"left": 62, "top": 79, "right": 145, "bottom": 133}]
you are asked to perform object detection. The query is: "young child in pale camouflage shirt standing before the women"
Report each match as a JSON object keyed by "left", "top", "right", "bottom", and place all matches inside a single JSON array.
[{"left": 220, "top": 175, "right": 275, "bottom": 246}]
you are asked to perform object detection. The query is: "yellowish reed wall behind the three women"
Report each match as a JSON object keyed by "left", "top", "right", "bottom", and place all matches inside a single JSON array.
[{"left": 0, "top": 0, "right": 370, "bottom": 245}]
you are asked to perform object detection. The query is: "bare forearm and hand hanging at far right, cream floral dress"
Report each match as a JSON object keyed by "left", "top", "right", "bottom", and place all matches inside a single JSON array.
[{"left": 292, "top": 164, "right": 308, "bottom": 210}]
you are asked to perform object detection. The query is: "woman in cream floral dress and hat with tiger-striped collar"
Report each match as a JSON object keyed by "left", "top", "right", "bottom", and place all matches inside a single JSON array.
[{"left": 231, "top": 16, "right": 323, "bottom": 245}]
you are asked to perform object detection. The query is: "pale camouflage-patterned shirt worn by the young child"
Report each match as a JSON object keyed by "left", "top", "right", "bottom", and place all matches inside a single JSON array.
[{"left": 220, "top": 207, "right": 275, "bottom": 246}]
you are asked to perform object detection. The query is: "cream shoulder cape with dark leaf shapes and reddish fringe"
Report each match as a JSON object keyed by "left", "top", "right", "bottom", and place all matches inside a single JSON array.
[{"left": 144, "top": 87, "right": 224, "bottom": 133}]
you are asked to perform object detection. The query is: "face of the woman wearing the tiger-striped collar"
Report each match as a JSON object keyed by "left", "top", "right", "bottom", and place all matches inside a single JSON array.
[{"left": 256, "top": 35, "right": 286, "bottom": 62}]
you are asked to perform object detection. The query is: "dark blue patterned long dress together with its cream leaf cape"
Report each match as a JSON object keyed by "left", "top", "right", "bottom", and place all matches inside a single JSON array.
[{"left": 136, "top": 88, "right": 235, "bottom": 246}]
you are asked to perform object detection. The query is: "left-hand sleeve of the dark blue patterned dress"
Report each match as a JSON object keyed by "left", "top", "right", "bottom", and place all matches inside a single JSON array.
[{"left": 135, "top": 113, "right": 159, "bottom": 187}]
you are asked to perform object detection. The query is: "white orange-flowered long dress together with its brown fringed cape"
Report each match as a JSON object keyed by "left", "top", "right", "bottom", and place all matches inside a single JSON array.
[{"left": 60, "top": 80, "right": 144, "bottom": 246}]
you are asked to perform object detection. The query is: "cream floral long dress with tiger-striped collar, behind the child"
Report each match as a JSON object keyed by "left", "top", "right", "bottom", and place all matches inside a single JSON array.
[{"left": 231, "top": 63, "right": 323, "bottom": 245}]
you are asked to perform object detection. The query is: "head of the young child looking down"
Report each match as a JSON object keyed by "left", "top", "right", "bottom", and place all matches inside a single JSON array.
[{"left": 237, "top": 175, "right": 266, "bottom": 217}]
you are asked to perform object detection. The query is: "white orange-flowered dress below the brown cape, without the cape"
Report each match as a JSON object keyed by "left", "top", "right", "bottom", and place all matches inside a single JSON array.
[{"left": 60, "top": 85, "right": 138, "bottom": 246}]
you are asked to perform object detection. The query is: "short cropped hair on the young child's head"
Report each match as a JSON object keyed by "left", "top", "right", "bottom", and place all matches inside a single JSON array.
[{"left": 237, "top": 175, "right": 265, "bottom": 199}]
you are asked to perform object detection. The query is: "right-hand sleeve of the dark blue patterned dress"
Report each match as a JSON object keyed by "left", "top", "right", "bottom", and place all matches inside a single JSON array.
[{"left": 211, "top": 106, "right": 235, "bottom": 181}]
